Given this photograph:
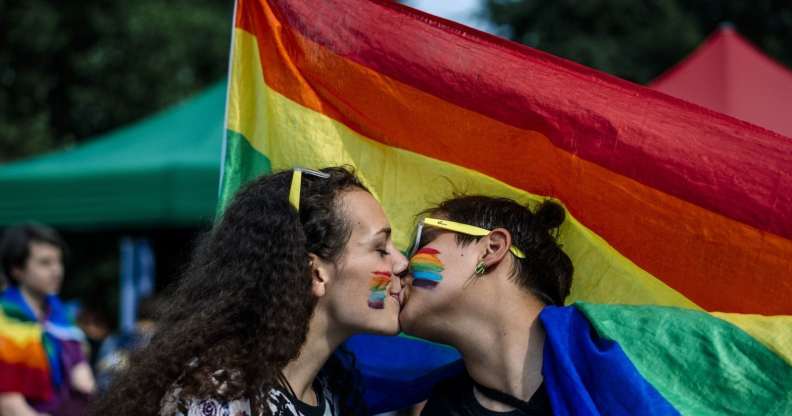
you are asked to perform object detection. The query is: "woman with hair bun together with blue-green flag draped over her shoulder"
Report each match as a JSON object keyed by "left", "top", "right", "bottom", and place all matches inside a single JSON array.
[{"left": 399, "top": 196, "right": 792, "bottom": 416}]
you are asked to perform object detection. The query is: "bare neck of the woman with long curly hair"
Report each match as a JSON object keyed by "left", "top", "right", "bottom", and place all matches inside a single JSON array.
[{"left": 283, "top": 303, "right": 351, "bottom": 406}]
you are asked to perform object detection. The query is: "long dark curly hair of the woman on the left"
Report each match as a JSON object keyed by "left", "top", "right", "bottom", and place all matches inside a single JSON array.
[{"left": 92, "top": 167, "right": 366, "bottom": 416}]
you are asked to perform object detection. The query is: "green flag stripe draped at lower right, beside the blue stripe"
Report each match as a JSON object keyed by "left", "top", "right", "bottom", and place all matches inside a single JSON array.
[{"left": 575, "top": 302, "right": 792, "bottom": 415}]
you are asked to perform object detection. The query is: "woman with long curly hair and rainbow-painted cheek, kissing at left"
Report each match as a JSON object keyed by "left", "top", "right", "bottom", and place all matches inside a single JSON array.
[{"left": 93, "top": 167, "right": 407, "bottom": 416}]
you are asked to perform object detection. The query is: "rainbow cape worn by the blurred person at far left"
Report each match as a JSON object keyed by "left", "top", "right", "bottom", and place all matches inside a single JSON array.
[{"left": 0, "top": 286, "right": 84, "bottom": 402}]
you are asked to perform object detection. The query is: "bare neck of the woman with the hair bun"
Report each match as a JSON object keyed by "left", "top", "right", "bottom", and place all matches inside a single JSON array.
[{"left": 457, "top": 298, "right": 545, "bottom": 411}]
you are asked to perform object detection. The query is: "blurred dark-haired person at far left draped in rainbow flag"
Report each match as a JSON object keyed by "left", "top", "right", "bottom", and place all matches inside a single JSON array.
[{"left": 0, "top": 224, "right": 95, "bottom": 416}]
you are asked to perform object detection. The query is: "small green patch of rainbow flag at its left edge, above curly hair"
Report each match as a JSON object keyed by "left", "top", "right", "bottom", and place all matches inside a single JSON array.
[{"left": 217, "top": 129, "right": 272, "bottom": 215}]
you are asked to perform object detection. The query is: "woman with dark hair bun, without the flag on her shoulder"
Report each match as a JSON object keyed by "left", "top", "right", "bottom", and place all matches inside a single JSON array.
[{"left": 400, "top": 196, "right": 573, "bottom": 415}]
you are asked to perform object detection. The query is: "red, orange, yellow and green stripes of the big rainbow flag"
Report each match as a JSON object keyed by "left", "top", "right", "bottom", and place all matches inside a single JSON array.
[{"left": 221, "top": 0, "right": 792, "bottom": 414}]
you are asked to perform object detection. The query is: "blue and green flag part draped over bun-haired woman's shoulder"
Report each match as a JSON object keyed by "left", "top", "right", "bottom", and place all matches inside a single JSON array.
[{"left": 539, "top": 302, "right": 792, "bottom": 415}]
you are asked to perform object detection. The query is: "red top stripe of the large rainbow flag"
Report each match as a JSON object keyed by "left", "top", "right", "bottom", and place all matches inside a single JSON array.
[{"left": 238, "top": 0, "right": 792, "bottom": 238}]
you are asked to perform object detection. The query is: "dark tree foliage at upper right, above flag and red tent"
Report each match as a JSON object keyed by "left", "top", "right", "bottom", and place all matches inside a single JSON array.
[{"left": 484, "top": 0, "right": 792, "bottom": 83}]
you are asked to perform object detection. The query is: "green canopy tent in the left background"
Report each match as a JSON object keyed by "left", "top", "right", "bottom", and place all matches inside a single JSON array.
[{"left": 0, "top": 82, "right": 226, "bottom": 229}]
